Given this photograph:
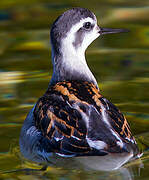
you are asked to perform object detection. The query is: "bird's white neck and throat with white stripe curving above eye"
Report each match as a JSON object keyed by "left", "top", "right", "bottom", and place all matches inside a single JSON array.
[{"left": 51, "top": 18, "right": 98, "bottom": 87}]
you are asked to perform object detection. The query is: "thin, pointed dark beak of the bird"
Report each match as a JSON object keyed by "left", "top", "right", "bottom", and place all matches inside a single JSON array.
[{"left": 98, "top": 28, "right": 129, "bottom": 35}]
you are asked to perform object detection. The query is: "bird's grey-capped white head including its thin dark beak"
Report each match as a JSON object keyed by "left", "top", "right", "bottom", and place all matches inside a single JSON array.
[{"left": 51, "top": 8, "right": 127, "bottom": 54}]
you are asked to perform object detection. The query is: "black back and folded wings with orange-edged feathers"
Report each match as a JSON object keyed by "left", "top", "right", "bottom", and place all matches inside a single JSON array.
[{"left": 34, "top": 82, "right": 137, "bottom": 156}]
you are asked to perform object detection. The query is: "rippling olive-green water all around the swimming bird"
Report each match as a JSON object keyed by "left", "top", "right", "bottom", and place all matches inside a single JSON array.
[{"left": 0, "top": 0, "right": 149, "bottom": 180}]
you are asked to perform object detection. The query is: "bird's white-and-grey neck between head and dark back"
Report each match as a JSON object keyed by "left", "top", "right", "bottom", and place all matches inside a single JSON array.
[{"left": 50, "top": 44, "right": 98, "bottom": 87}]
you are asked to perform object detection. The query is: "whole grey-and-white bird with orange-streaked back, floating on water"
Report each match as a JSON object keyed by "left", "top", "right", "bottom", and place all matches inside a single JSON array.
[{"left": 19, "top": 7, "right": 139, "bottom": 169}]
